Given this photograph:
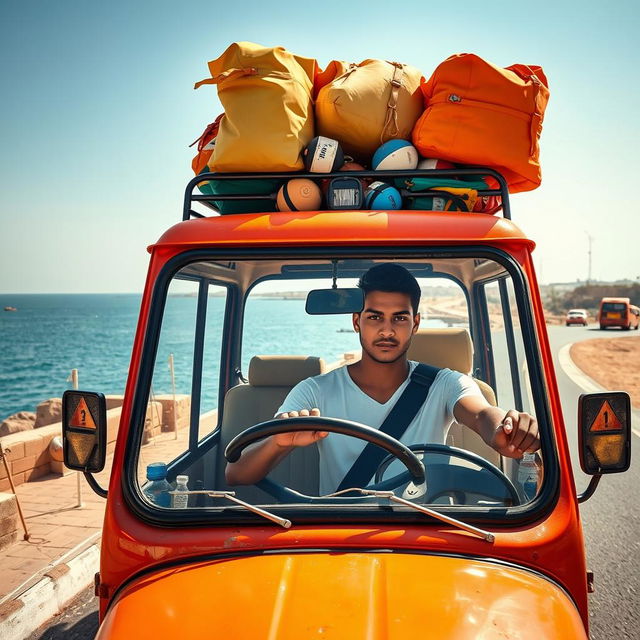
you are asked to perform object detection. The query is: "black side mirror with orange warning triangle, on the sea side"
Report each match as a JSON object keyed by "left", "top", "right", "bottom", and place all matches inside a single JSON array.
[{"left": 62, "top": 391, "right": 107, "bottom": 473}]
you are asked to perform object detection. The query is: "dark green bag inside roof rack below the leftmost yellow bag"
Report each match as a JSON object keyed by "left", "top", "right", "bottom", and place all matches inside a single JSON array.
[{"left": 198, "top": 167, "right": 285, "bottom": 215}]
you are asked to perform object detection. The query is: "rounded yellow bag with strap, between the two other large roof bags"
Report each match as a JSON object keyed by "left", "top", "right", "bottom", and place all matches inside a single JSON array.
[{"left": 316, "top": 60, "right": 424, "bottom": 163}]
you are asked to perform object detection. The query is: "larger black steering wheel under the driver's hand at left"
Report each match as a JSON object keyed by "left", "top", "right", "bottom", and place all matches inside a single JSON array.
[{"left": 224, "top": 416, "right": 425, "bottom": 503}]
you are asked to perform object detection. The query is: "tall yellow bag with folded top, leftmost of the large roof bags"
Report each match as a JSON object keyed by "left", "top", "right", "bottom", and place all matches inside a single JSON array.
[{"left": 195, "top": 42, "right": 317, "bottom": 173}]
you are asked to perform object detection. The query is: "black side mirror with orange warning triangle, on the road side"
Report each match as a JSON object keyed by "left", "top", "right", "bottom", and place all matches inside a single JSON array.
[{"left": 578, "top": 391, "right": 631, "bottom": 475}]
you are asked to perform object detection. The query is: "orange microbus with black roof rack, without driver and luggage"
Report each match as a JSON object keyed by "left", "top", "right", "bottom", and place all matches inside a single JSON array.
[{"left": 63, "top": 168, "right": 630, "bottom": 640}]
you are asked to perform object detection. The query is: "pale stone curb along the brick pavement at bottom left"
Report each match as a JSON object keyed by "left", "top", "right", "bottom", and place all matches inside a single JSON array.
[{"left": 0, "top": 540, "right": 100, "bottom": 640}]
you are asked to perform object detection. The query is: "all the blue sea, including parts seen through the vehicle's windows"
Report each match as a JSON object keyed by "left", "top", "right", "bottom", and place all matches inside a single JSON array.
[{"left": 0, "top": 294, "right": 448, "bottom": 422}]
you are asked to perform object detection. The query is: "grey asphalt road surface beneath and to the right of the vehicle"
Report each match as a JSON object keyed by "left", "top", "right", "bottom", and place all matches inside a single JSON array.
[{"left": 32, "top": 326, "right": 640, "bottom": 640}]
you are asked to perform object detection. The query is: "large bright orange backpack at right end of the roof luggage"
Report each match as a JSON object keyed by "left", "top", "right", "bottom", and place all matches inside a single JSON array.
[{"left": 413, "top": 53, "right": 549, "bottom": 193}]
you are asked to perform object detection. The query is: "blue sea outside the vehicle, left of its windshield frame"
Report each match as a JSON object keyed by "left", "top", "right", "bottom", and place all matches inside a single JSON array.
[{"left": 0, "top": 294, "right": 141, "bottom": 420}]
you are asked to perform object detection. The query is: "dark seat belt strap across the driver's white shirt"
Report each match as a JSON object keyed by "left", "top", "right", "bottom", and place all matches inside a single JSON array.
[{"left": 337, "top": 363, "right": 440, "bottom": 491}]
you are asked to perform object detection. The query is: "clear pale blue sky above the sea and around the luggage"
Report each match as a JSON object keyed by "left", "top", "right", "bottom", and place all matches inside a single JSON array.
[{"left": 0, "top": 0, "right": 640, "bottom": 293}]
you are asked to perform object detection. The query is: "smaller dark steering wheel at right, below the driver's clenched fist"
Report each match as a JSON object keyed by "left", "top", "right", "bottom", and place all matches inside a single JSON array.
[{"left": 374, "top": 444, "right": 522, "bottom": 505}]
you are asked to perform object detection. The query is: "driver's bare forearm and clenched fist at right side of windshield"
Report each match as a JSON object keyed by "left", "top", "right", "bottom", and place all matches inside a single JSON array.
[{"left": 453, "top": 395, "right": 540, "bottom": 458}]
